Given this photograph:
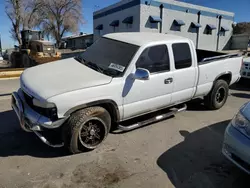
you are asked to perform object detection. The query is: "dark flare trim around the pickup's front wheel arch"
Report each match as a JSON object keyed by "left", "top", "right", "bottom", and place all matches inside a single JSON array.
[{"left": 64, "top": 99, "right": 120, "bottom": 122}]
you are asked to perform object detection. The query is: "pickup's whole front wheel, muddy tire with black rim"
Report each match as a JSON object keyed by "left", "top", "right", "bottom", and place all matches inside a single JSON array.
[{"left": 62, "top": 106, "right": 111, "bottom": 154}]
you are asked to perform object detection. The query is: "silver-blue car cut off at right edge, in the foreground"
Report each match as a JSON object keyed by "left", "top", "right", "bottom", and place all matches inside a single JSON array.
[{"left": 222, "top": 102, "right": 250, "bottom": 174}]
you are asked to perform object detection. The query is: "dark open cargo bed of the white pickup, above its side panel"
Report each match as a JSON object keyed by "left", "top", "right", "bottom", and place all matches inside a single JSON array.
[{"left": 196, "top": 49, "right": 239, "bottom": 65}]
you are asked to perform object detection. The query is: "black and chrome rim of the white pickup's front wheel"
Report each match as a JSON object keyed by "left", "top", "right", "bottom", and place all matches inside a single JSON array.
[{"left": 79, "top": 117, "right": 107, "bottom": 149}]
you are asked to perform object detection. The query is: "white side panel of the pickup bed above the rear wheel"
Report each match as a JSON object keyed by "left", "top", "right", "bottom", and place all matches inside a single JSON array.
[{"left": 196, "top": 57, "right": 242, "bottom": 97}]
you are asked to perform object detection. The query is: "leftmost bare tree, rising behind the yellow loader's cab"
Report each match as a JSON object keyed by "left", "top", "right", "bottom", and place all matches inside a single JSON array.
[{"left": 5, "top": 0, "right": 43, "bottom": 45}]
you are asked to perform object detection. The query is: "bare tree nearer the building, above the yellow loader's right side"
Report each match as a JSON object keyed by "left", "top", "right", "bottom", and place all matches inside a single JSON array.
[{"left": 39, "top": 0, "right": 83, "bottom": 44}]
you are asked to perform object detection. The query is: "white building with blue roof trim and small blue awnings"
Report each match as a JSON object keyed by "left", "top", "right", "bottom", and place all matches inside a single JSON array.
[{"left": 93, "top": 0, "right": 234, "bottom": 50}]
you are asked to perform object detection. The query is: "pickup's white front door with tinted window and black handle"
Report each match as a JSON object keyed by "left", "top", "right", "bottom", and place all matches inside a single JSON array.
[{"left": 123, "top": 44, "right": 173, "bottom": 120}]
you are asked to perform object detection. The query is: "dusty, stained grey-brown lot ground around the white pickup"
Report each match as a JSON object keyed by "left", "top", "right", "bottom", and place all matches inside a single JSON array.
[{"left": 0, "top": 80, "right": 250, "bottom": 188}]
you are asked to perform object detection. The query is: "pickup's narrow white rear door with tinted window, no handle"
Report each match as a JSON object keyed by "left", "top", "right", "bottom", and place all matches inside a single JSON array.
[{"left": 171, "top": 43, "right": 198, "bottom": 104}]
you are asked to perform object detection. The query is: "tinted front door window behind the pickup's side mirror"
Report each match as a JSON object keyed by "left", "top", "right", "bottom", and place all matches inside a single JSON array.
[{"left": 136, "top": 45, "right": 169, "bottom": 73}]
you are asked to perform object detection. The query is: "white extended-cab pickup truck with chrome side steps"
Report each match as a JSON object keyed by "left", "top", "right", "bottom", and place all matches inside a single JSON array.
[{"left": 12, "top": 33, "right": 242, "bottom": 153}]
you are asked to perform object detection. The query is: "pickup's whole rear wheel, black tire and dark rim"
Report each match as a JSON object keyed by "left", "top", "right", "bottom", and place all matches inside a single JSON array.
[{"left": 204, "top": 80, "right": 229, "bottom": 110}]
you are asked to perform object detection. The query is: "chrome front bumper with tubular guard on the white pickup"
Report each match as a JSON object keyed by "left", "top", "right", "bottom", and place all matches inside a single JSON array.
[{"left": 11, "top": 89, "right": 67, "bottom": 147}]
